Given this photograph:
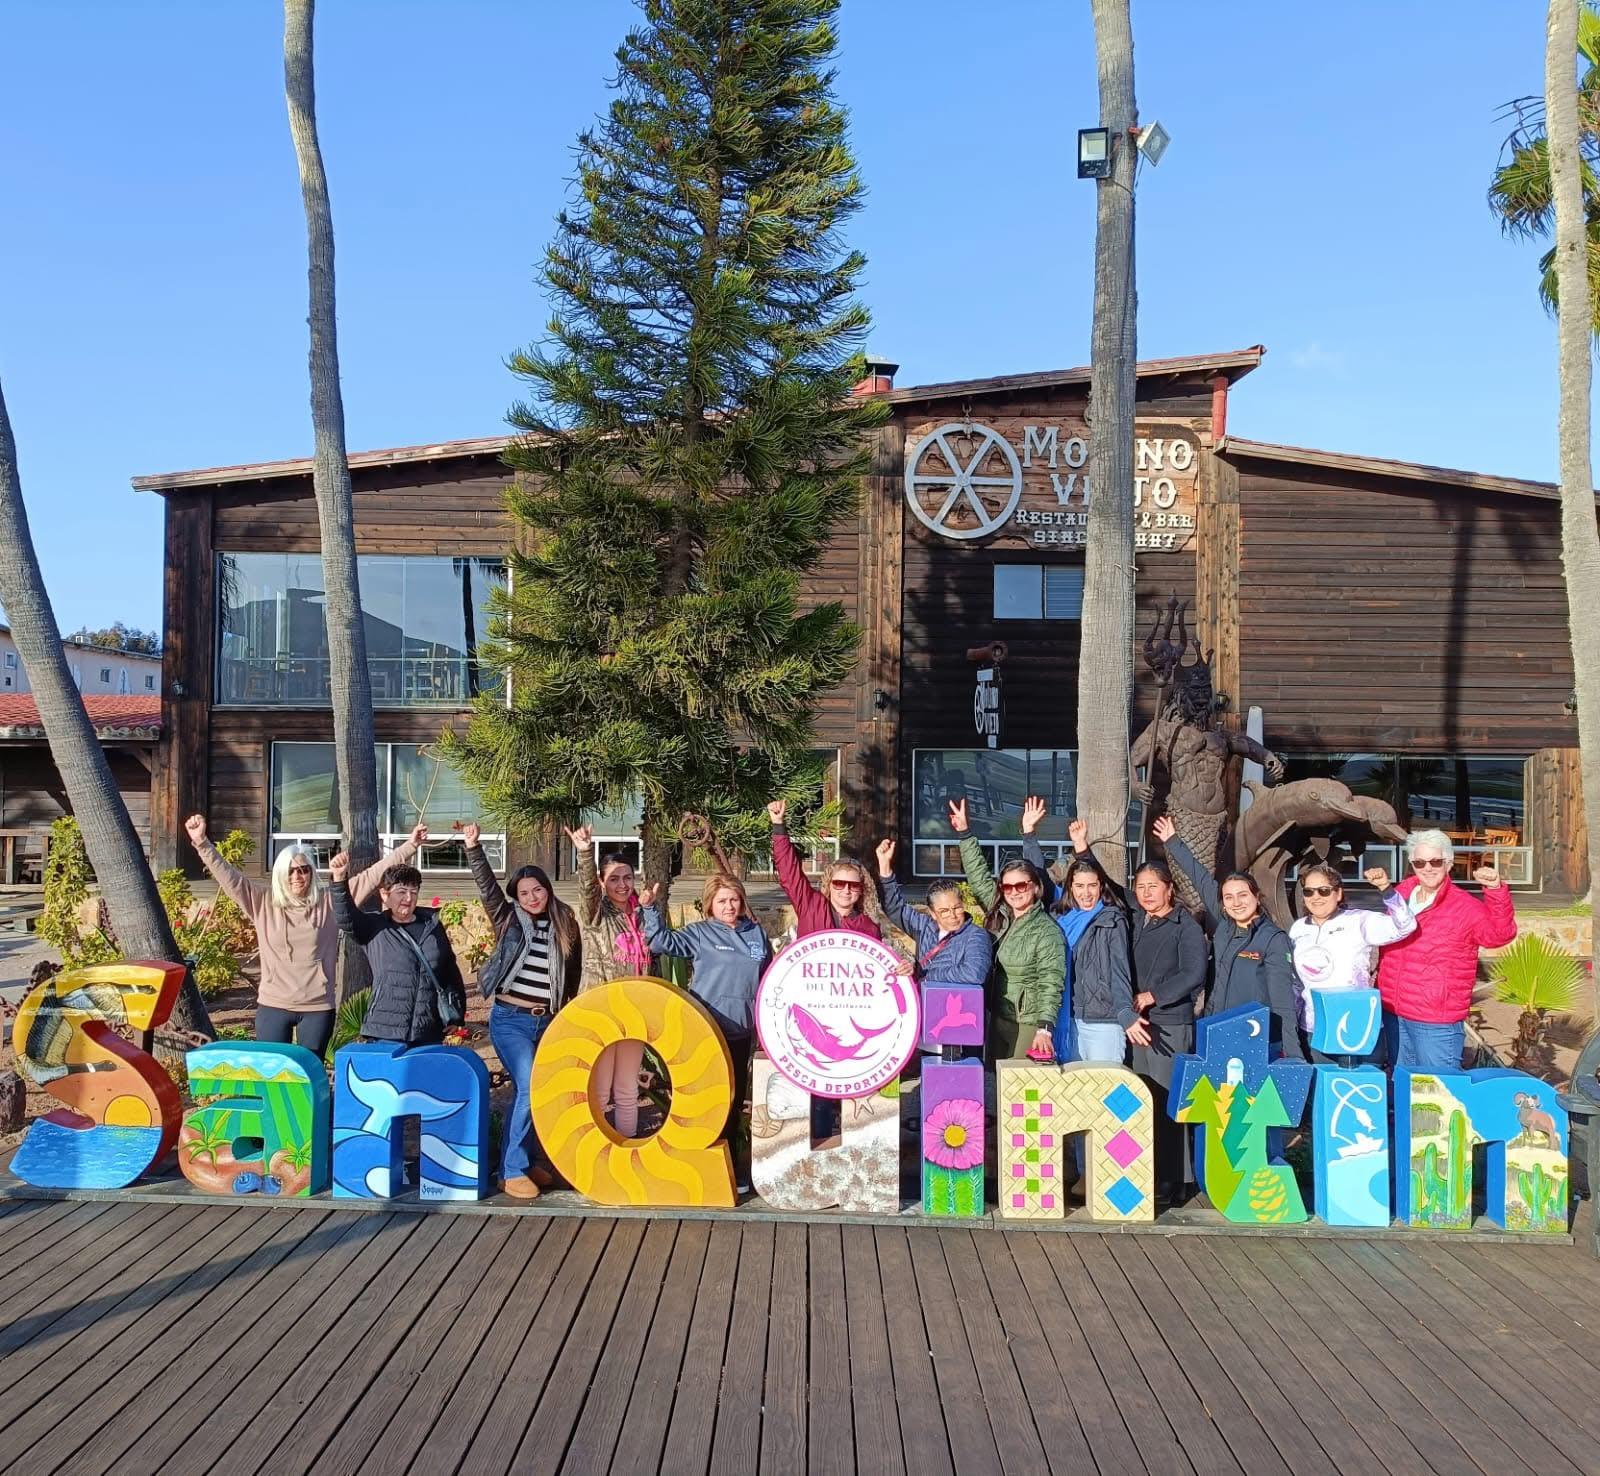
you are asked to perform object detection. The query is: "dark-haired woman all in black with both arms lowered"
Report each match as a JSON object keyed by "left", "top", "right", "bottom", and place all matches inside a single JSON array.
[{"left": 1133, "top": 861, "right": 1210, "bottom": 1204}]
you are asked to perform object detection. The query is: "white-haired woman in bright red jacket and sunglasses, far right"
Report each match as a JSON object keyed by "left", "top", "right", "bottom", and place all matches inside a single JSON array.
[{"left": 1378, "top": 831, "right": 1517, "bottom": 1071}]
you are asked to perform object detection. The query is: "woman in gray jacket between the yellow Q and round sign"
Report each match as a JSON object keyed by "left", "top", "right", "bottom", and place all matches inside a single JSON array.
[{"left": 638, "top": 871, "right": 773, "bottom": 1193}]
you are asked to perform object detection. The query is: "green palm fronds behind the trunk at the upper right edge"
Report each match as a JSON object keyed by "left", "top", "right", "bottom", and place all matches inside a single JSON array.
[{"left": 1490, "top": 0, "right": 1600, "bottom": 335}]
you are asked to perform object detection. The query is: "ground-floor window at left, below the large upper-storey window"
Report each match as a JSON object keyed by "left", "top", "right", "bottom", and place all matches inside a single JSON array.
[{"left": 269, "top": 743, "right": 506, "bottom": 871}]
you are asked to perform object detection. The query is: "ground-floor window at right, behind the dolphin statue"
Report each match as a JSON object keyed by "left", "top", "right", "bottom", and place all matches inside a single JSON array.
[{"left": 1285, "top": 754, "right": 1536, "bottom": 885}]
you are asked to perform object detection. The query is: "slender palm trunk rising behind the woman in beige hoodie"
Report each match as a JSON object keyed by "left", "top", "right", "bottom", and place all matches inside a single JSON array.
[{"left": 283, "top": 0, "right": 378, "bottom": 866}]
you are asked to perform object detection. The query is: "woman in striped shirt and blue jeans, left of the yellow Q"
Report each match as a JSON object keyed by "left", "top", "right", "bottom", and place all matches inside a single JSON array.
[{"left": 462, "top": 824, "right": 581, "bottom": 1199}]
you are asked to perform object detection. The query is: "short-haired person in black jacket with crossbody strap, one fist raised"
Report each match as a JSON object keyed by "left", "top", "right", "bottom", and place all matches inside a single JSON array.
[{"left": 328, "top": 852, "right": 467, "bottom": 1045}]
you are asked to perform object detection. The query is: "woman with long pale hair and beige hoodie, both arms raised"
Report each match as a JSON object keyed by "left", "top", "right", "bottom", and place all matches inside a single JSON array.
[{"left": 184, "top": 815, "right": 427, "bottom": 1057}]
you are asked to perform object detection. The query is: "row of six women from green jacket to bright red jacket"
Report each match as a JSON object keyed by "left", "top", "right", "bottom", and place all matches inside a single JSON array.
[{"left": 930, "top": 797, "right": 1517, "bottom": 1201}]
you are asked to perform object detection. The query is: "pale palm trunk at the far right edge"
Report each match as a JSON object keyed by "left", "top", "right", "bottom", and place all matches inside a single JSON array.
[{"left": 1544, "top": 0, "right": 1600, "bottom": 1005}]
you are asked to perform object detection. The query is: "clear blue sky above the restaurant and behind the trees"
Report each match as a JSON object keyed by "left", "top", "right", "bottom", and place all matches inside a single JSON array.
[{"left": 0, "top": 0, "right": 1574, "bottom": 628}]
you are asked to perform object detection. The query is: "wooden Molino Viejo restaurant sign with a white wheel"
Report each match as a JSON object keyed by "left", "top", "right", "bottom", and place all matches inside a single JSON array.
[{"left": 906, "top": 418, "right": 1200, "bottom": 552}]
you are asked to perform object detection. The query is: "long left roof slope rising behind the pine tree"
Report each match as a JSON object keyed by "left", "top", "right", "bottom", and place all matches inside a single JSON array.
[{"left": 133, "top": 344, "right": 1267, "bottom": 491}]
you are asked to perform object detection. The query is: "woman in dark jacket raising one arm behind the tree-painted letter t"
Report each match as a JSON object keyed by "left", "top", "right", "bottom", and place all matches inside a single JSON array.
[{"left": 1150, "top": 815, "right": 1306, "bottom": 1061}]
